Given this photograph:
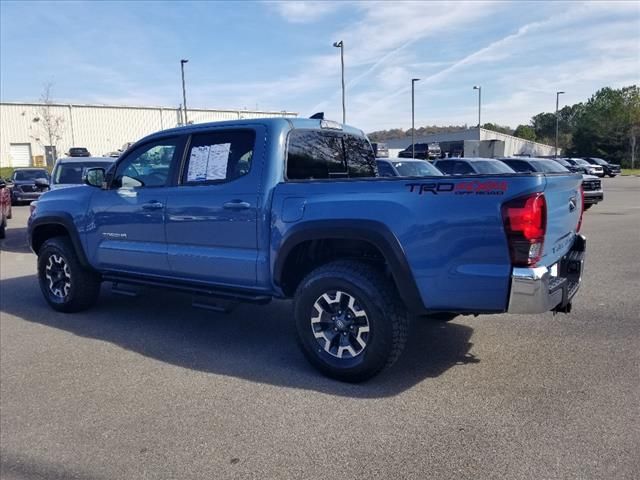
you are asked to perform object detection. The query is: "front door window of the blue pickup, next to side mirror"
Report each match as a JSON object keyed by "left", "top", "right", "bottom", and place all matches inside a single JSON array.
[{"left": 112, "top": 138, "right": 182, "bottom": 188}]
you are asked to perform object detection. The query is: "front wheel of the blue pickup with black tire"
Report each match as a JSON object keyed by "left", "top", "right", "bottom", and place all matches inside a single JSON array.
[{"left": 38, "top": 237, "right": 100, "bottom": 313}]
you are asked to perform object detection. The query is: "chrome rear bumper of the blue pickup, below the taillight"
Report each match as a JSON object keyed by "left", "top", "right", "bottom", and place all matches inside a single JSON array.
[{"left": 507, "top": 235, "right": 586, "bottom": 313}]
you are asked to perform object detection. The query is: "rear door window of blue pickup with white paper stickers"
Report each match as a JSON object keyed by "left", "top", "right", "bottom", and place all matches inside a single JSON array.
[{"left": 182, "top": 129, "right": 256, "bottom": 185}]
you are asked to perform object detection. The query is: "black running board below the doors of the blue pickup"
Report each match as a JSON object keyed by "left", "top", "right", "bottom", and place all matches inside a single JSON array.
[{"left": 102, "top": 273, "right": 271, "bottom": 304}]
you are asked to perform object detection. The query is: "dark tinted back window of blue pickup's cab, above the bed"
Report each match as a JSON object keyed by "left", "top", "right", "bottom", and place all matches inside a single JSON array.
[{"left": 287, "top": 130, "right": 376, "bottom": 180}]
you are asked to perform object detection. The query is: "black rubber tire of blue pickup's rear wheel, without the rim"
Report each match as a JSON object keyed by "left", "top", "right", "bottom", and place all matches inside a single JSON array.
[{"left": 293, "top": 260, "right": 409, "bottom": 382}]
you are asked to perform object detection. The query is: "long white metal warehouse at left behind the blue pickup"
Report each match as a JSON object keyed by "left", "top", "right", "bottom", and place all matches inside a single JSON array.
[{"left": 0, "top": 102, "right": 297, "bottom": 167}]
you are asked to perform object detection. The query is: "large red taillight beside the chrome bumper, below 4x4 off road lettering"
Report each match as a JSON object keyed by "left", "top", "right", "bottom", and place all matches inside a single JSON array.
[{"left": 502, "top": 193, "right": 547, "bottom": 267}]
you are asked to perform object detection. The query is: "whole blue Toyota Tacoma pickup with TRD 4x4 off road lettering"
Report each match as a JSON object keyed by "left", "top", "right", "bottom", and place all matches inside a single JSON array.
[{"left": 28, "top": 119, "right": 585, "bottom": 381}]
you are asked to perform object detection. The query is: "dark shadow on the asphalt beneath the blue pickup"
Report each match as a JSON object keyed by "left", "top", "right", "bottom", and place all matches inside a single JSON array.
[{"left": 0, "top": 275, "right": 479, "bottom": 398}]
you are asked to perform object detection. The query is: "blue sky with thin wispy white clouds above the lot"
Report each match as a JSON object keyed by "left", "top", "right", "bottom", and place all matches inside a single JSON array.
[{"left": 0, "top": 1, "right": 640, "bottom": 132}]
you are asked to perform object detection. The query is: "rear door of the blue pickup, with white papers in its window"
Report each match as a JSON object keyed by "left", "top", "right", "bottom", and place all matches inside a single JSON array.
[{"left": 166, "top": 126, "right": 265, "bottom": 287}]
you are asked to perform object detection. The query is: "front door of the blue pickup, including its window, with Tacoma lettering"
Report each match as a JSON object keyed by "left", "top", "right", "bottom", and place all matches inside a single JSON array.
[{"left": 87, "top": 137, "right": 184, "bottom": 275}]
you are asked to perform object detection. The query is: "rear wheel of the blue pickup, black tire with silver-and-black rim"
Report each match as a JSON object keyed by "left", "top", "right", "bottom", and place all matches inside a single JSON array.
[{"left": 293, "top": 260, "right": 409, "bottom": 382}]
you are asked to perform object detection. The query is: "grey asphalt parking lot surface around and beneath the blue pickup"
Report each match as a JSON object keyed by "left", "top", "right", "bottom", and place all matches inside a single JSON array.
[{"left": 0, "top": 177, "right": 640, "bottom": 480}]
